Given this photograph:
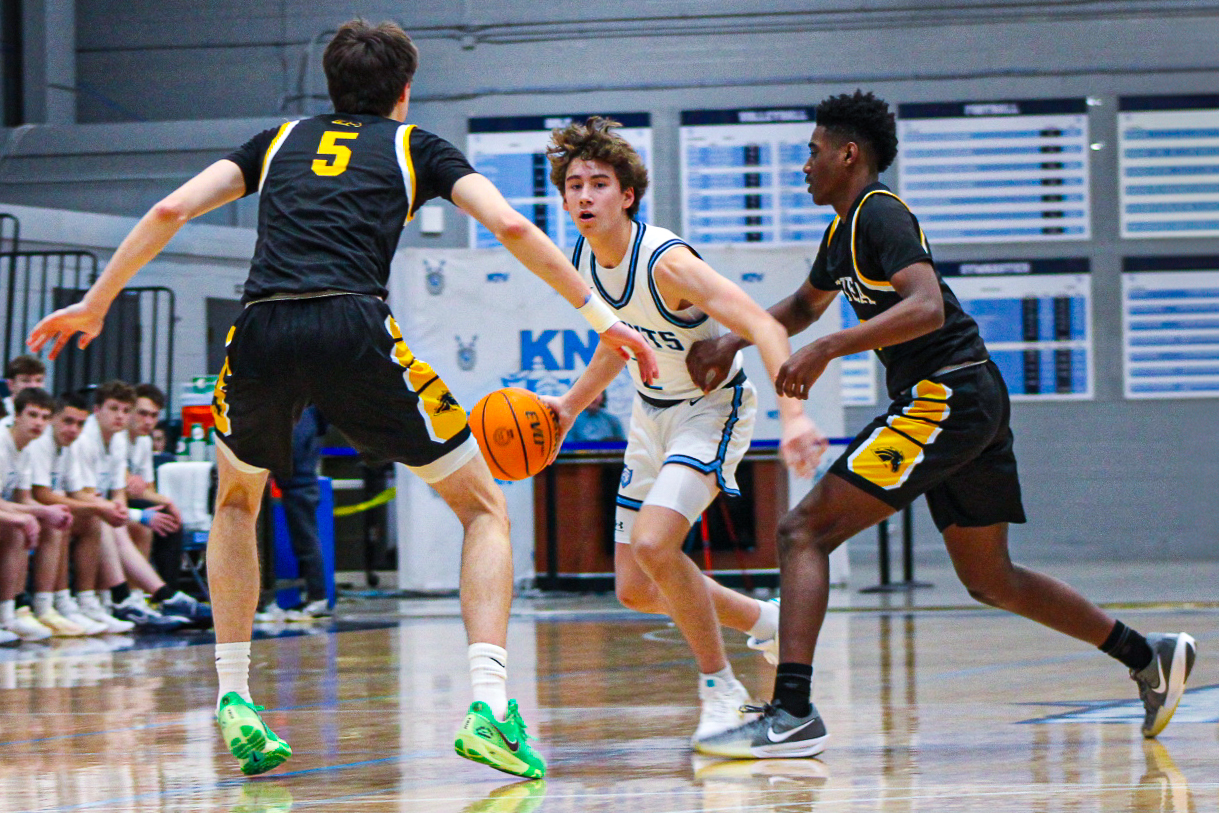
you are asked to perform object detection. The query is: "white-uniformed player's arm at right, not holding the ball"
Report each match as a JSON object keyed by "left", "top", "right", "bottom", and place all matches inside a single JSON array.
[{"left": 655, "top": 247, "right": 829, "bottom": 477}]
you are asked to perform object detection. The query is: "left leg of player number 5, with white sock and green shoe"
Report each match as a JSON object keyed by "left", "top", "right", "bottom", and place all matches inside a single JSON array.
[{"left": 209, "top": 441, "right": 293, "bottom": 775}]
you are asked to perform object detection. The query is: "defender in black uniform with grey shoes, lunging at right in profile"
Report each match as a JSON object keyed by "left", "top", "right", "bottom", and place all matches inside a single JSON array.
[{"left": 689, "top": 91, "right": 1195, "bottom": 757}]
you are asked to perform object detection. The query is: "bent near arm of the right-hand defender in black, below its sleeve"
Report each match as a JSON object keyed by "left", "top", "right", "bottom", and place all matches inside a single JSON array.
[{"left": 774, "top": 262, "right": 944, "bottom": 399}]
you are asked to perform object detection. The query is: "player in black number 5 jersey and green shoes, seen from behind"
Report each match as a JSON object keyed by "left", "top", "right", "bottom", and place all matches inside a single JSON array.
[{"left": 29, "top": 20, "right": 656, "bottom": 778}]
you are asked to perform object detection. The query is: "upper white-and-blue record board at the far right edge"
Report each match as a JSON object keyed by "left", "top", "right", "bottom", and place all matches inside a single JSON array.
[{"left": 1118, "top": 95, "right": 1219, "bottom": 238}]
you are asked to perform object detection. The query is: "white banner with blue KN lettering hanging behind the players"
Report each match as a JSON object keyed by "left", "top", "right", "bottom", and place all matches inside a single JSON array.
[{"left": 389, "top": 246, "right": 844, "bottom": 590}]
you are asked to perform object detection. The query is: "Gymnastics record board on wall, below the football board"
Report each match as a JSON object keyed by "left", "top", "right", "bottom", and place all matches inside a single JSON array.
[{"left": 936, "top": 258, "right": 1093, "bottom": 401}]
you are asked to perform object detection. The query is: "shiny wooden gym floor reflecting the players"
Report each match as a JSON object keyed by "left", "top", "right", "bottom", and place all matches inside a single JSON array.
[{"left": 0, "top": 572, "right": 1219, "bottom": 813}]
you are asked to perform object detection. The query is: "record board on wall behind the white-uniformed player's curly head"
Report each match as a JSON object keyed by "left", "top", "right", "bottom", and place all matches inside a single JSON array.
[{"left": 466, "top": 113, "right": 655, "bottom": 249}]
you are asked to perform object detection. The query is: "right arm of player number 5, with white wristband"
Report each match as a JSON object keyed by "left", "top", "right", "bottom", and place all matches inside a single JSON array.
[{"left": 452, "top": 173, "right": 659, "bottom": 384}]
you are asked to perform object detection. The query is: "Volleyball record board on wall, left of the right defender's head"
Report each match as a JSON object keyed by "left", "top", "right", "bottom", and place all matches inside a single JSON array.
[{"left": 680, "top": 107, "right": 834, "bottom": 246}]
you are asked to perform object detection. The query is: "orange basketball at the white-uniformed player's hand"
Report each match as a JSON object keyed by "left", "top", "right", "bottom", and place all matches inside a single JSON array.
[{"left": 469, "top": 386, "right": 558, "bottom": 480}]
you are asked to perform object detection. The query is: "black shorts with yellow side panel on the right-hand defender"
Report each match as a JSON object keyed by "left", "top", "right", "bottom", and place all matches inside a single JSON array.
[{"left": 830, "top": 361, "right": 1024, "bottom": 531}]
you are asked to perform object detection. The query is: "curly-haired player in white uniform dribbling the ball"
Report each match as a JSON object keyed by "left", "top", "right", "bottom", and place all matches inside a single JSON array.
[{"left": 547, "top": 117, "right": 826, "bottom": 748}]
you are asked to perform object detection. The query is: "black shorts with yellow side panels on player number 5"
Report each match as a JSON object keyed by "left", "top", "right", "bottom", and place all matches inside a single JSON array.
[{"left": 212, "top": 295, "right": 478, "bottom": 483}]
